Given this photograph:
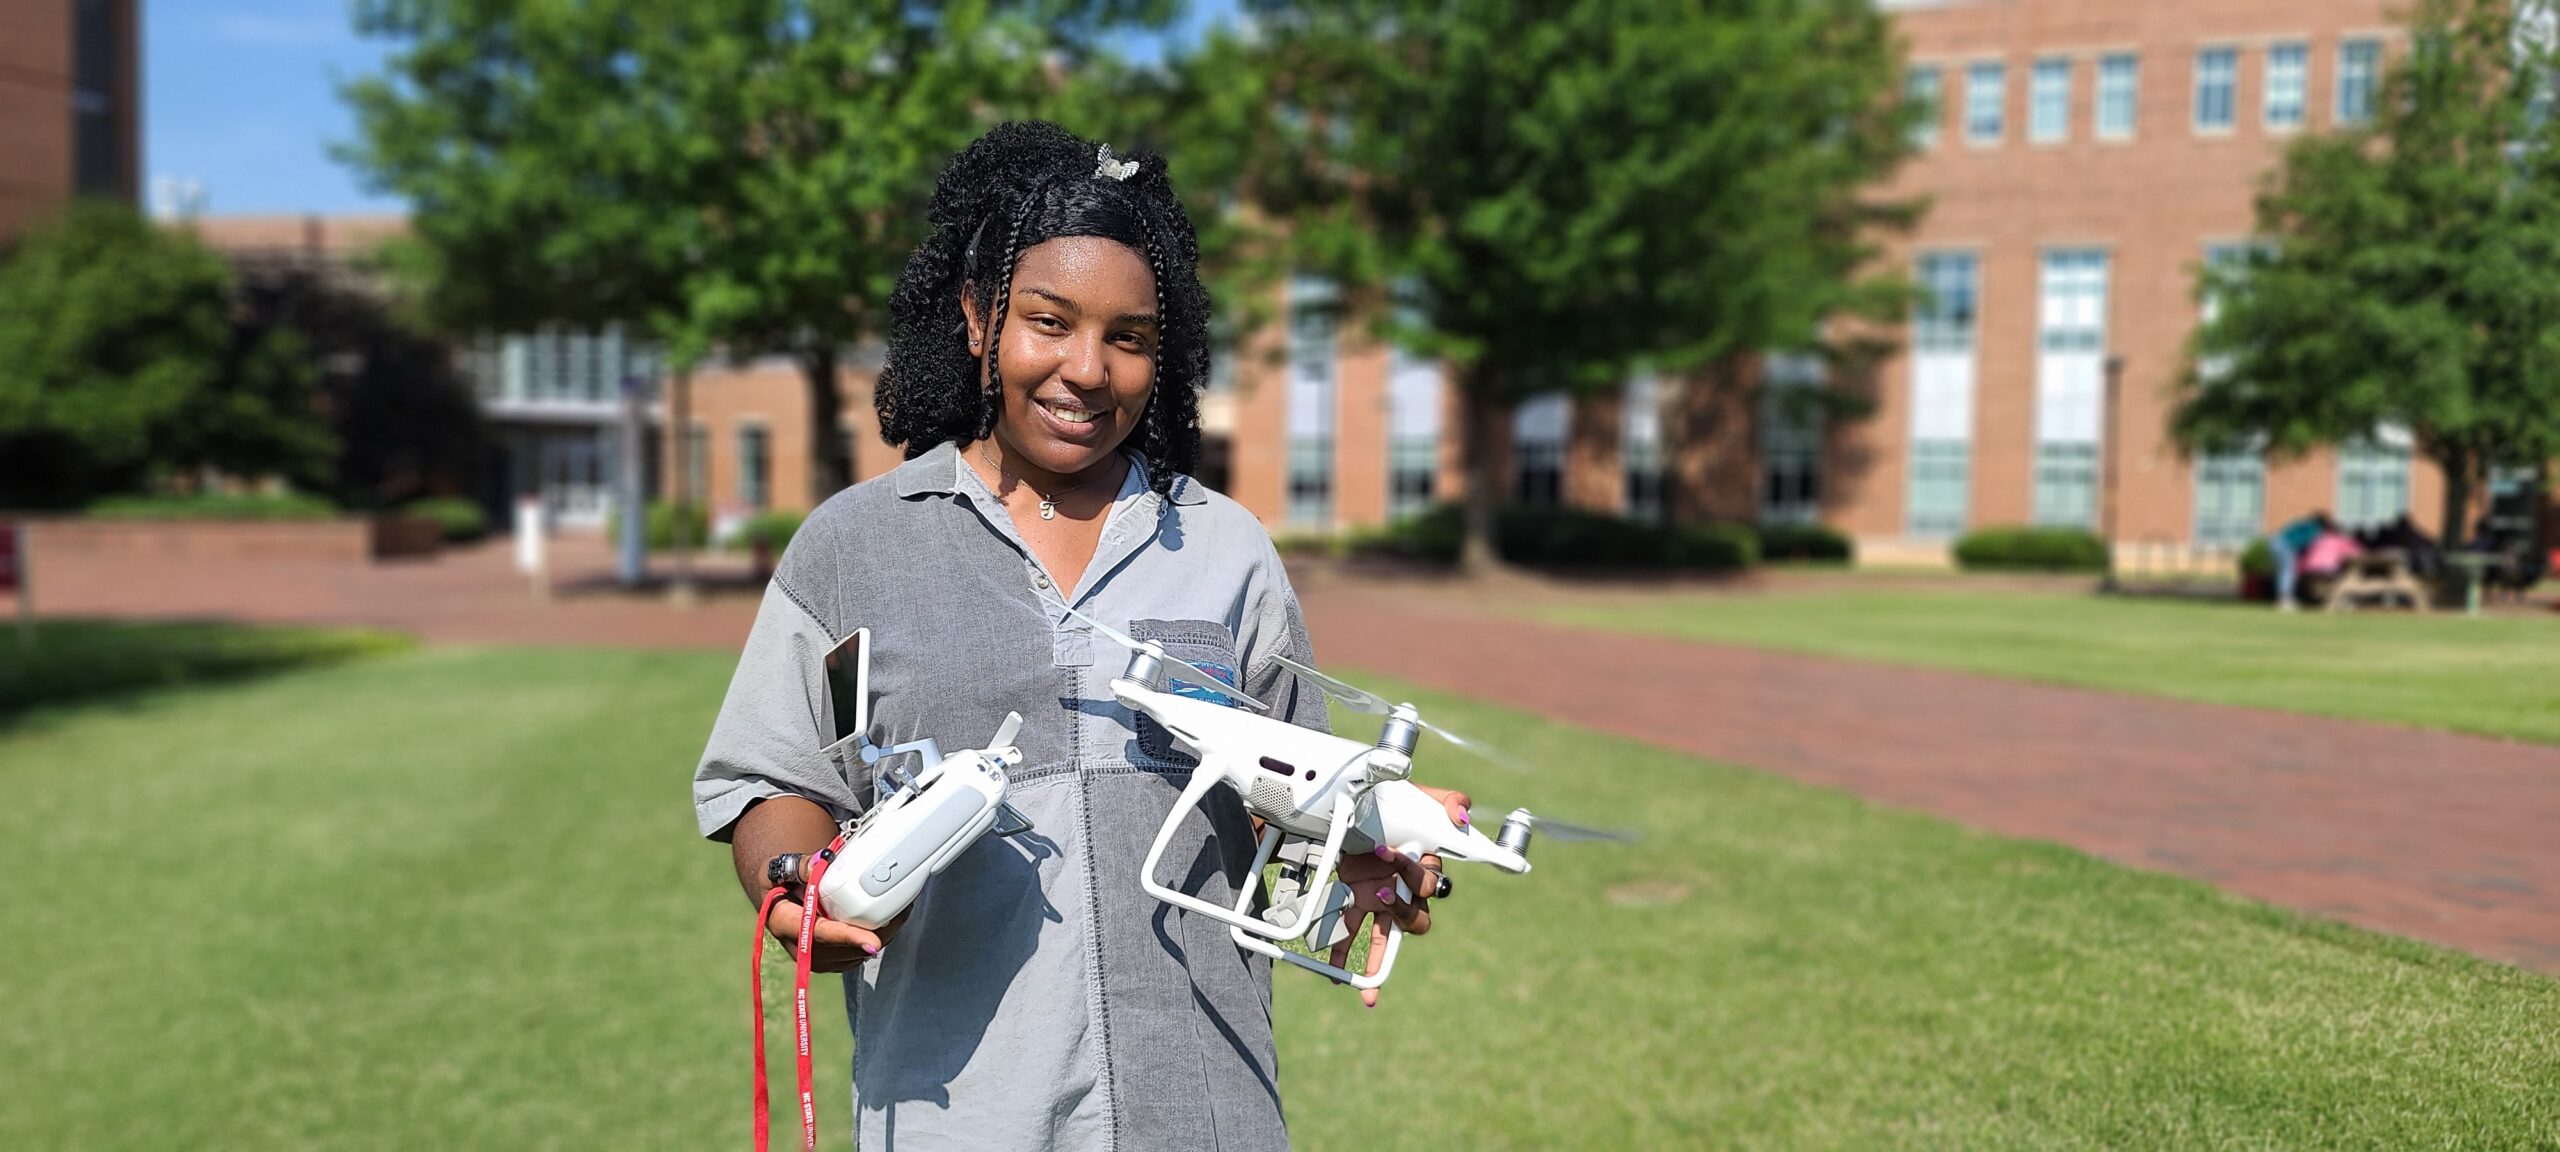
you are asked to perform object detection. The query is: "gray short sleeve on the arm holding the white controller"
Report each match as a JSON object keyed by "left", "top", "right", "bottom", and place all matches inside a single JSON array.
[{"left": 694, "top": 581, "right": 860, "bottom": 840}]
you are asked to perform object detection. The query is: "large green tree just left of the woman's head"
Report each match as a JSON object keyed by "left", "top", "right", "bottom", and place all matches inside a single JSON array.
[{"left": 346, "top": 0, "right": 1170, "bottom": 504}]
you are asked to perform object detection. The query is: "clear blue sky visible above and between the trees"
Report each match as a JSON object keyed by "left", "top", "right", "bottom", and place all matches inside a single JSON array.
[{"left": 143, "top": 0, "right": 1234, "bottom": 215}]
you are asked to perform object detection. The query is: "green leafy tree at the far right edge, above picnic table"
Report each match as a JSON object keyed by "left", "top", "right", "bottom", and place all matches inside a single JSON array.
[{"left": 2173, "top": 0, "right": 2560, "bottom": 535}]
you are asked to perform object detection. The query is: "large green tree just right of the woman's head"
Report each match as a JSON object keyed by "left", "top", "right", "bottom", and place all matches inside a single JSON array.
[{"left": 1206, "top": 0, "right": 1917, "bottom": 566}]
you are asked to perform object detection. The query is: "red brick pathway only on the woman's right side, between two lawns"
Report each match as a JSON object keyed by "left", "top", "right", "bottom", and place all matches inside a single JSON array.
[{"left": 1300, "top": 579, "right": 2560, "bottom": 970}]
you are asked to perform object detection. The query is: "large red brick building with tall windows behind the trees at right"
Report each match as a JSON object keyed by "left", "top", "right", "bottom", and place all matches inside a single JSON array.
[{"left": 1229, "top": 0, "right": 2437, "bottom": 563}]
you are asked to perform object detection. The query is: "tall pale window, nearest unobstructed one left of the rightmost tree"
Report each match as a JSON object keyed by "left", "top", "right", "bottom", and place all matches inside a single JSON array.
[{"left": 2033, "top": 251, "right": 2107, "bottom": 527}]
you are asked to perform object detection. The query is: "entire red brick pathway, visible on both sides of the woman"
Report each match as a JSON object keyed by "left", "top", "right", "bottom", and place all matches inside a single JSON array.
[{"left": 36, "top": 540, "right": 2560, "bottom": 970}]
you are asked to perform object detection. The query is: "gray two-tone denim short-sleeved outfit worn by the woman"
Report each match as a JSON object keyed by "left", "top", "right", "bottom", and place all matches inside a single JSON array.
[{"left": 694, "top": 445, "right": 1326, "bottom": 1149}]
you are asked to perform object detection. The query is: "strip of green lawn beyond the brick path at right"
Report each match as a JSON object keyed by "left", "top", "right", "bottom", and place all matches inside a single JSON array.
[{"left": 1536, "top": 589, "right": 2560, "bottom": 742}]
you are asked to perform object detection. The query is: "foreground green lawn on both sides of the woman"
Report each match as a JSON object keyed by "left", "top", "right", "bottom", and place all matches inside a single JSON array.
[{"left": 0, "top": 650, "right": 2560, "bottom": 1149}]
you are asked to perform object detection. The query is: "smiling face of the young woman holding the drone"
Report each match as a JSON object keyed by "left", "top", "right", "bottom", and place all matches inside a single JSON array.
[{"left": 963, "top": 236, "right": 1162, "bottom": 476}]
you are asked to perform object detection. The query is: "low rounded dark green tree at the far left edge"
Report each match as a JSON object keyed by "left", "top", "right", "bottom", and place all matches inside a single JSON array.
[{"left": 0, "top": 200, "right": 333, "bottom": 507}]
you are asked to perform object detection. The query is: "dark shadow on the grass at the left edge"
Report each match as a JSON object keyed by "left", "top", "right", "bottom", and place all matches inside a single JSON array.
[{"left": 0, "top": 620, "right": 415, "bottom": 732}]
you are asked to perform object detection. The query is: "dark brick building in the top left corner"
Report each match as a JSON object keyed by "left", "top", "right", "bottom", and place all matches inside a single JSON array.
[{"left": 0, "top": 0, "right": 141, "bottom": 241}]
